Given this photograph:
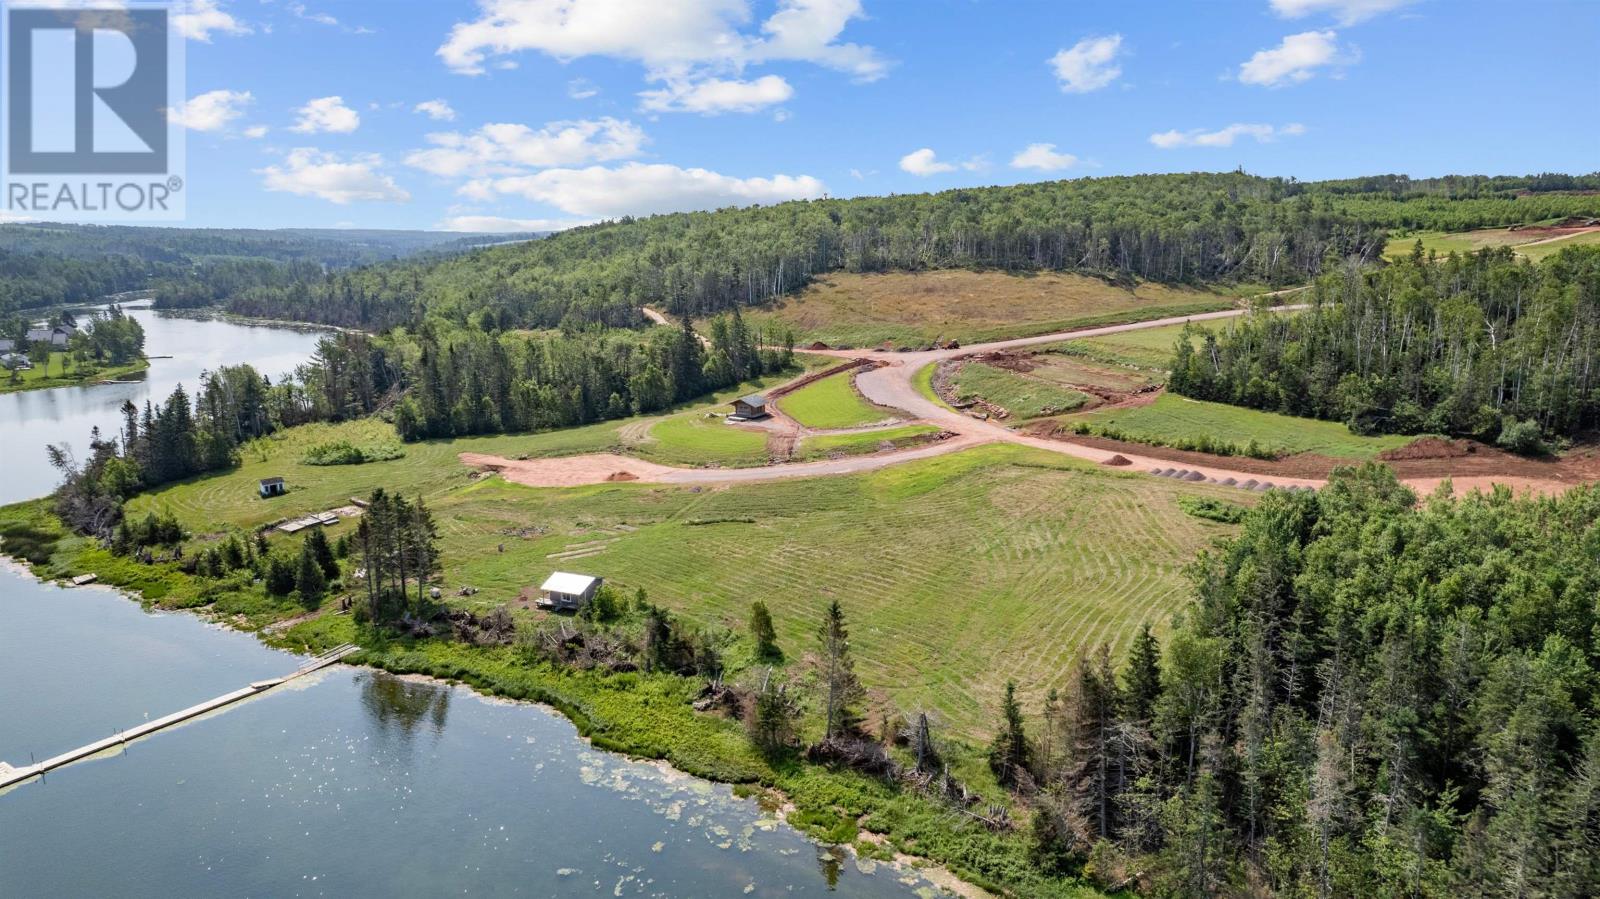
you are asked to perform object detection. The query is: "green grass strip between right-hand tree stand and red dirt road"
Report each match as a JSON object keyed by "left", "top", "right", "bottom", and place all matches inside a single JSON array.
[{"left": 1064, "top": 394, "right": 1414, "bottom": 459}]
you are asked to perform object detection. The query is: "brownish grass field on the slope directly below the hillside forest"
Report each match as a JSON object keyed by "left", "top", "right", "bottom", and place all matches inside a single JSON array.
[{"left": 746, "top": 270, "right": 1248, "bottom": 347}]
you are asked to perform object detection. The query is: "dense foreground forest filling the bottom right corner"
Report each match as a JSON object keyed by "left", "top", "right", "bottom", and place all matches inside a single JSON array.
[{"left": 992, "top": 464, "right": 1600, "bottom": 897}]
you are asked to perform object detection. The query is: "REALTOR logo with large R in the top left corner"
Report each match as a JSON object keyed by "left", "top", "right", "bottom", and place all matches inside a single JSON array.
[{"left": 3, "top": 5, "right": 182, "bottom": 221}]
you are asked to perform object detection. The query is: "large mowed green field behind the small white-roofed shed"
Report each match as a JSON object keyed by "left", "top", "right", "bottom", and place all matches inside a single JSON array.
[{"left": 412, "top": 446, "right": 1237, "bottom": 736}]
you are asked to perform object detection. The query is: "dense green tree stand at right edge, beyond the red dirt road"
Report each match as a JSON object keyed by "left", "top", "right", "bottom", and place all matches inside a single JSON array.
[{"left": 1170, "top": 246, "right": 1600, "bottom": 451}]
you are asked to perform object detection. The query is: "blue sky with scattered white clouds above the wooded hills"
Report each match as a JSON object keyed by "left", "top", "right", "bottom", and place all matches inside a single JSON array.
[{"left": 165, "top": 0, "right": 1600, "bottom": 230}]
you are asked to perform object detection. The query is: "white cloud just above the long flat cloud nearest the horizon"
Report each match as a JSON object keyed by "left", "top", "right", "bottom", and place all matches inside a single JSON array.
[{"left": 405, "top": 117, "right": 645, "bottom": 178}]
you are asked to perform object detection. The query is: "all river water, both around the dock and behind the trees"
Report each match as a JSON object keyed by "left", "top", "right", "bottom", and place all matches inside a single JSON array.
[{"left": 0, "top": 310, "right": 938, "bottom": 897}]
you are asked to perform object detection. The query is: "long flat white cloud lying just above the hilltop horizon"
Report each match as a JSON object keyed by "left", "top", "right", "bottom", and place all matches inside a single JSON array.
[{"left": 459, "top": 162, "right": 827, "bottom": 219}]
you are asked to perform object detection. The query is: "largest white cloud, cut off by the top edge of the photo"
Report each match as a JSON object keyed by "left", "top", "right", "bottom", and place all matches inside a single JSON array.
[{"left": 438, "top": 0, "right": 888, "bottom": 80}]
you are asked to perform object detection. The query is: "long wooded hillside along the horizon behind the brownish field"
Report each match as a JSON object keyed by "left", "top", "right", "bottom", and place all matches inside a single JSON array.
[{"left": 134, "top": 173, "right": 1600, "bottom": 331}]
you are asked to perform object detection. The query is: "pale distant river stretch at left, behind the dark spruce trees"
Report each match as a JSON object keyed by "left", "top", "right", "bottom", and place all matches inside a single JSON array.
[{"left": 0, "top": 309, "right": 320, "bottom": 505}]
